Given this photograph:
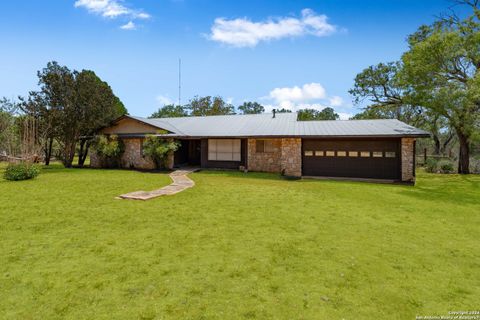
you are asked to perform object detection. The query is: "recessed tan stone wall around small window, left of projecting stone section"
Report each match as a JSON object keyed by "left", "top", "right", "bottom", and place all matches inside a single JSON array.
[{"left": 247, "top": 139, "right": 282, "bottom": 173}]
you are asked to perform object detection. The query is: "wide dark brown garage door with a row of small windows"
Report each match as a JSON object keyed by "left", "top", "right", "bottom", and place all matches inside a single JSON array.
[{"left": 302, "top": 139, "right": 400, "bottom": 180}]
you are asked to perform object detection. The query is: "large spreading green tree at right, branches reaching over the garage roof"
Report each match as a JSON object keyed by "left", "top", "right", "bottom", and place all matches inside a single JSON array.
[{"left": 350, "top": 0, "right": 480, "bottom": 173}]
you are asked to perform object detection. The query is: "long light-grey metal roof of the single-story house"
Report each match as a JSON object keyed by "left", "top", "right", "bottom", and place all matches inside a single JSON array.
[{"left": 129, "top": 113, "right": 430, "bottom": 137}]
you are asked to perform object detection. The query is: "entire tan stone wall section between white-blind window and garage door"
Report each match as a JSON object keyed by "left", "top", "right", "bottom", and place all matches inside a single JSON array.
[{"left": 247, "top": 138, "right": 302, "bottom": 177}]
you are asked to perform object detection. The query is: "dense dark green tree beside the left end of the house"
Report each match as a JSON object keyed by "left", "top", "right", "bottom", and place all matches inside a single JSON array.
[{"left": 38, "top": 62, "right": 126, "bottom": 167}]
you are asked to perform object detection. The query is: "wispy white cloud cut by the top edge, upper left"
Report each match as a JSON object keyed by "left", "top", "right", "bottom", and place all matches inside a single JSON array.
[{"left": 74, "top": 0, "right": 151, "bottom": 26}]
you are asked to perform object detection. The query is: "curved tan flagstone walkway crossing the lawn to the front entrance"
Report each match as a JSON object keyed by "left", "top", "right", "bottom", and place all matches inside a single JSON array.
[{"left": 118, "top": 168, "right": 199, "bottom": 200}]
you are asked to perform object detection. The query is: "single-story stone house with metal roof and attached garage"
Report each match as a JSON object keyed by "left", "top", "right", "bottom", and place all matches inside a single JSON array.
[{"left": 91, "top": 112, "right": 429, "bottom": 183}]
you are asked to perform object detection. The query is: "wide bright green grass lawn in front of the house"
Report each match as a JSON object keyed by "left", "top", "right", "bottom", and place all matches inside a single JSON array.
[{"left": 0, "top": 165, "right": 480, "bottom": 319}]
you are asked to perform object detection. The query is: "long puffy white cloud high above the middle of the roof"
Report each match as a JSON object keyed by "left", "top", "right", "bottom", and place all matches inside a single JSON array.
[{"left": 209, "top": 9, "right": 337, "bottom": 47}]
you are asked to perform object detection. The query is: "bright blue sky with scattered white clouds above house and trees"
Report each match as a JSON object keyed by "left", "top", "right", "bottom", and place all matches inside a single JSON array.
[{"left": 0, "top": 0, "right": 464, "bottom": 117}]
